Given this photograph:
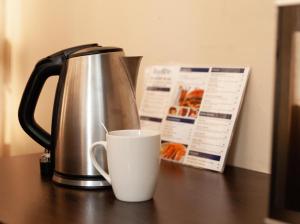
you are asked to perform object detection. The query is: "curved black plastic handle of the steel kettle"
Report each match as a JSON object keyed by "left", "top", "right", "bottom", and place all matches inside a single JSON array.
[{"left": 18, "top": 58, "right": 63, "bottom": 149}]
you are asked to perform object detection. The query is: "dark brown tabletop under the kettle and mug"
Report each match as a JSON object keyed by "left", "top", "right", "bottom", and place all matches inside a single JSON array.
[{"left": 0, "top": 154, "right": 270, "bottom": 224}]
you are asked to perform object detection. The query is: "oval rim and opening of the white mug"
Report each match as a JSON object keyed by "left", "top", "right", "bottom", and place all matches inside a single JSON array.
[{"left": 106, "top": 129, "right": 160, "bottom": 138}]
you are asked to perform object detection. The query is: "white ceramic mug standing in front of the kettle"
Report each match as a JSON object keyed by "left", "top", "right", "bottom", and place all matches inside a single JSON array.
[{"left": 90, "top": 130, "right": 160, "bottom": 202}]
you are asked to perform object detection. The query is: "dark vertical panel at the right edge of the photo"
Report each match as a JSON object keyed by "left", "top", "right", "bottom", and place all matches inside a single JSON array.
[{"left": 269, "top": 6, "right": 300, "bottom": 223}]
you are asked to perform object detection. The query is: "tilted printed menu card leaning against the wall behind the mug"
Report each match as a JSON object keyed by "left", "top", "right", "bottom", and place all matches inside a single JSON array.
[{"left": 139, "top": 66, "right": 250, "bottom": 172}]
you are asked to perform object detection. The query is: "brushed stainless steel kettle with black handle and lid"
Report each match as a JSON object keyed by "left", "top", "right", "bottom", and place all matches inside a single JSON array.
[{"left": 18, "top": 44, "right": 141, "bottom": 188}]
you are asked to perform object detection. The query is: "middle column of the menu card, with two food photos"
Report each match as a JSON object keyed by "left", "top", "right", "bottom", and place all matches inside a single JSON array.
[{"left": 161, "top": 67, "right": 209, "bottom": 162}]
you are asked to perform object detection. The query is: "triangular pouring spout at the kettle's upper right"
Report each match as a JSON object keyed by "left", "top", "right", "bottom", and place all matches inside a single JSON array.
[{"left": 122, "top": 56, "right": 142, "bottom": 90}]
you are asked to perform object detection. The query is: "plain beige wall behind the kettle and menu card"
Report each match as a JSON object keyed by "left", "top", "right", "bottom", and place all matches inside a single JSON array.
[{"left": 5, "top": 0, "right": 276, "bottom": 172}]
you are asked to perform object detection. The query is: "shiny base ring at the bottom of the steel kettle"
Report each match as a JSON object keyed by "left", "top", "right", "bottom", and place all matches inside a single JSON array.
[{"left": 52, "top": 172, "right": 111, "bottom": 189}]
